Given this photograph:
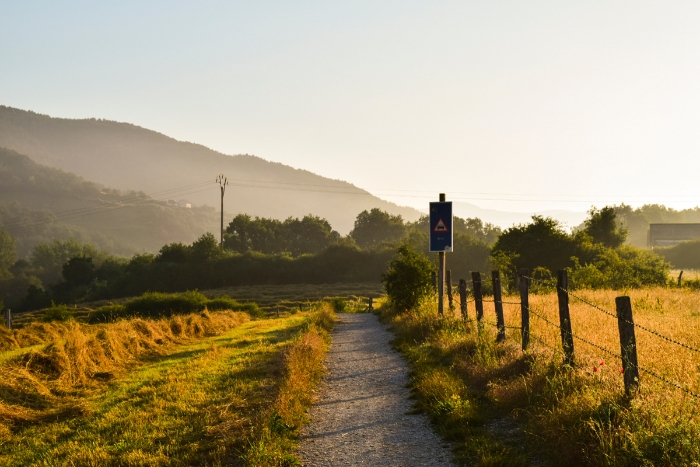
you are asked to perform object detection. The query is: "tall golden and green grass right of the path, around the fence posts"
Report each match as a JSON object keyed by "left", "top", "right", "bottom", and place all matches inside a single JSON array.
[{"left": 382, "top": 288, "right": 700, "bottom": 466}]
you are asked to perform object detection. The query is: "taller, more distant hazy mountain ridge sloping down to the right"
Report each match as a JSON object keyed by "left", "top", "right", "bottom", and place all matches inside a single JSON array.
[{"left": 0, "top": 106, "right": 420, "bottom": 234}]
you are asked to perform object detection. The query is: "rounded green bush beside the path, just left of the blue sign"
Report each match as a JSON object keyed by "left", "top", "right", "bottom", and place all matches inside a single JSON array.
[{"left": 382, "top": 245, "right": 434, "bottom": 311}]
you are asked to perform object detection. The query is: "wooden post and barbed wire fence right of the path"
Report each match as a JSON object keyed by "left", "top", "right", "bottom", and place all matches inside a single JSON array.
[{"left": 438, "top": 269, "right": 700, "bottom": 398}]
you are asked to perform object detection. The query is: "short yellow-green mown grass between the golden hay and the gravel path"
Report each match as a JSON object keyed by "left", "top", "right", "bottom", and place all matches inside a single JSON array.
[{"left": 0, "top": 308, "right": 332, "bottom": 466}]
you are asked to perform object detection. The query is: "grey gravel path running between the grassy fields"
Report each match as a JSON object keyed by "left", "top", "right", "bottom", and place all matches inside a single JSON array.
[{"left": 299, "top": 314, "right": 454, "bottom": 467}]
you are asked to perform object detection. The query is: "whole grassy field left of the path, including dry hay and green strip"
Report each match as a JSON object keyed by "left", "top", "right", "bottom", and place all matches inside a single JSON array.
[{"left": 0, "top": 304, "right": 333, "bottom": 466}]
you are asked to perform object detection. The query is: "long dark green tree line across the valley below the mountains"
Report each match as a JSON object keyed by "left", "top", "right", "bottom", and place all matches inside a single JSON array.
[{"left": 0, "top": 207, "right": 684, "bottom": 310}]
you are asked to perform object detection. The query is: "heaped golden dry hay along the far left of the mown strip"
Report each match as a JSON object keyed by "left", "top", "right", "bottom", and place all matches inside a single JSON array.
[{"left": 0, "top": 312, "right": 249, "bottom": 436}]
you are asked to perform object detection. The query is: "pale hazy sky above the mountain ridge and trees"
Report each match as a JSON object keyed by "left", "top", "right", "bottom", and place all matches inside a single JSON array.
[{"left": 0, "top": 0, "right": 700, "bottom": 211}]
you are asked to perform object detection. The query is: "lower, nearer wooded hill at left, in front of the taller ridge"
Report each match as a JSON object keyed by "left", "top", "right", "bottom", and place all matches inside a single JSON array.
[{"left": 0, "top": 148, "right": 220, "bottom": 258}]
